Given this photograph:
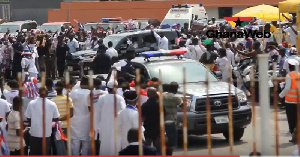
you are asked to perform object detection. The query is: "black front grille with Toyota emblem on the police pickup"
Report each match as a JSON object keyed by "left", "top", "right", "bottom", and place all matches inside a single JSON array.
[{"left": 195, "top": 96, "right": 239, "bottom": 112}]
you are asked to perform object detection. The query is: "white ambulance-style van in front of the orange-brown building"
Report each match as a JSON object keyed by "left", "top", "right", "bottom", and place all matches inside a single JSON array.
[{"left": 161, "top": 3, "right": 208, "bottom": 28}]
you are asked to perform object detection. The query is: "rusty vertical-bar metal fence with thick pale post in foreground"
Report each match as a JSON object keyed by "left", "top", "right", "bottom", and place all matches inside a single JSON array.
[{"left": 8, "top": 54, "right": 300, "bottom": 156}]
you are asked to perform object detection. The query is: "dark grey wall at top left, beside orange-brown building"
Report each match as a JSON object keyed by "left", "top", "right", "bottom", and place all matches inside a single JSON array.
[{"left": 10, "top": 0, "right": 63, "bottom": 24}]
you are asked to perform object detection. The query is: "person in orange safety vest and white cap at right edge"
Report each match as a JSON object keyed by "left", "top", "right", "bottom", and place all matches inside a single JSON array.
[{"left": 279, "top": 59, "right": 300, "bottom": 142}]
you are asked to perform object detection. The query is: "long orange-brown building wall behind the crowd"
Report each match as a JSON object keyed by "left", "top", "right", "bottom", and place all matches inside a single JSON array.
[{"left": 48, "top": 0, "right": 282, "bottom": 24}]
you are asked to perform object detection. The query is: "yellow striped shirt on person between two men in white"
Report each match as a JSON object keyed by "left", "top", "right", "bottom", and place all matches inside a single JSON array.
[{"left": 52, "top": 95, "right": 73, "bottom": 128}]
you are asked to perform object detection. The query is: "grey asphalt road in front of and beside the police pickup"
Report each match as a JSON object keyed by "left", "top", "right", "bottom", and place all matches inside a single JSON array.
[{"left": 174, "top": 105, "right": 296, "bottom": 156}]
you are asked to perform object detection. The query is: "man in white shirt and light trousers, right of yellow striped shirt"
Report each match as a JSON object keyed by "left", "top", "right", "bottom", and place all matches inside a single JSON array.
[{"left": 70, "top": 76, "right": 91, "bottom": 155}]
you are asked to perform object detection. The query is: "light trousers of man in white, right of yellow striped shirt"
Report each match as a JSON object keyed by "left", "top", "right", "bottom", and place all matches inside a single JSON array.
[{"left": 71, "top": 139, "right": 91, "bottom": 155}]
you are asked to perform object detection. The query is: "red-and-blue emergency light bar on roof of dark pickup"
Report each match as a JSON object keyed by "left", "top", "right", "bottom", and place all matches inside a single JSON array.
[{"left": 138, "top": 49, "right": 187, "bottom": 62}]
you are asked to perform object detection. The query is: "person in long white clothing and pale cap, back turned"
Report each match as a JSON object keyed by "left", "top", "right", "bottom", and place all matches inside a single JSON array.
[{"left": 94, "top": 81, "right": 126, "bottom": 155}]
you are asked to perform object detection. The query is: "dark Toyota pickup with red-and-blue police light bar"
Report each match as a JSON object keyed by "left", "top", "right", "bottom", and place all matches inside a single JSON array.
[{"left": 109, "top": 49, "right": 252, "bottom": 141}]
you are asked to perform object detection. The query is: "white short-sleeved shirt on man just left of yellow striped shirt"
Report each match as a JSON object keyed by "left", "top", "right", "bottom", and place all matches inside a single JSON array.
[{"left": 25, "top": 98, "right": 60, "bottom": 137}]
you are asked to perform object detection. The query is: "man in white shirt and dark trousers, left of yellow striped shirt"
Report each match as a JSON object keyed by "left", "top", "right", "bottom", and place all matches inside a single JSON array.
[{"left": 25, "top": 88, "right": 60, "bottom": 155}]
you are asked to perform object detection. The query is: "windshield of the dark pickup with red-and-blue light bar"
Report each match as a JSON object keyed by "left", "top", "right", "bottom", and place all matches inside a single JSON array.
[{"left": 147, "top": 62, "right": 218, "bottom": 84}]
